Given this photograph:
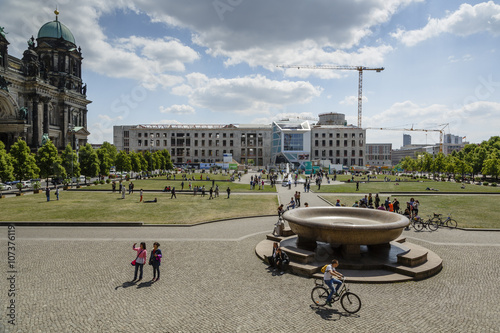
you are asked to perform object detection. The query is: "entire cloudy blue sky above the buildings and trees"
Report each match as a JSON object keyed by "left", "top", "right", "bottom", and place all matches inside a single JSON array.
[{"left": 0, "top": 0, "right": 500, "bottom": 148}]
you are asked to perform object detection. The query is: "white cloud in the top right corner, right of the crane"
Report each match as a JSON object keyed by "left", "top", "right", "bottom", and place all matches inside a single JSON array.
[{"left": 391, "top": 1, "right": 500, "bottom": 46}]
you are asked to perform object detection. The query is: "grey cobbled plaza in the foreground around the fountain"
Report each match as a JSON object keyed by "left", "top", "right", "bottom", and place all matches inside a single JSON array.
[{"left": 0, "top": 217, "right": 500, "bottom": 333}]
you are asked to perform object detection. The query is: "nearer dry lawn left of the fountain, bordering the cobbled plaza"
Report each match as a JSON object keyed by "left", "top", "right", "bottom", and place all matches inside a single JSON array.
[{"left": 0, "top": 191, "right": 278, "bottom": 224}]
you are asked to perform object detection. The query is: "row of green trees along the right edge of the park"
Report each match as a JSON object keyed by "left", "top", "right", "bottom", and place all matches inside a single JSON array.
[{"left": 400, "top": 136, "right": 500, "bottom": 179}]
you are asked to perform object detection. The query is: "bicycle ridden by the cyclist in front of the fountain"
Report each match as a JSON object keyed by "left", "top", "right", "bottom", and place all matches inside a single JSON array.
[{"left": 311, "top": 278, "right": 361, "bottom": 313}]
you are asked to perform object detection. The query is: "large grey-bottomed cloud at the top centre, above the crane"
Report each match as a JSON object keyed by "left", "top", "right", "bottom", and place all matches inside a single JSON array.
[{"left": 138, "top": 0, "right": 414, "bottom": 69}]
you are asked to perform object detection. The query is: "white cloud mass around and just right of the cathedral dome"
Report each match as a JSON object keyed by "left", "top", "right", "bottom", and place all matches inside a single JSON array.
[{"left": 0, "top": 0, "right": 200, "bottom": 90}]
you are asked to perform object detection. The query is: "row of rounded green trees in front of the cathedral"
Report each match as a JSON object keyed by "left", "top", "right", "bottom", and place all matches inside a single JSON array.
[{"left": 0, "top": 139, "right": 173, "bottom": 182}]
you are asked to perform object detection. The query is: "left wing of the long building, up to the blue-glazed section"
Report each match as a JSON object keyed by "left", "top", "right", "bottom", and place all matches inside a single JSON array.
[{"left": 113, "top": 124, "right": 271, "bottom": 165}]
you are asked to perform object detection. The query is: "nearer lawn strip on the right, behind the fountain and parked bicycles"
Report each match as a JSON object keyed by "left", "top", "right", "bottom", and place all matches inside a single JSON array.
[{"left": 323, "top": 193, "right": 500, "bottom": 228}]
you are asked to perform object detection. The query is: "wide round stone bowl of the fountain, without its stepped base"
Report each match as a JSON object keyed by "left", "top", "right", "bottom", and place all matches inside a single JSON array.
[{"left": 283, "top": 207, "right": 410, "bottom": 245}]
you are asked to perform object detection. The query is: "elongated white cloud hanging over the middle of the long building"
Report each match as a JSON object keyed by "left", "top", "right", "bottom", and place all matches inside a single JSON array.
[{"left": 172, "top": 73, "right": 322, "bottom": 113}]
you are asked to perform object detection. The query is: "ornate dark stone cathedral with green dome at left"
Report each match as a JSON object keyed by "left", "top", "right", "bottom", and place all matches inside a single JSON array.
[{"left": 0, "top": 11, "right": 91, "bottom": 151}]
